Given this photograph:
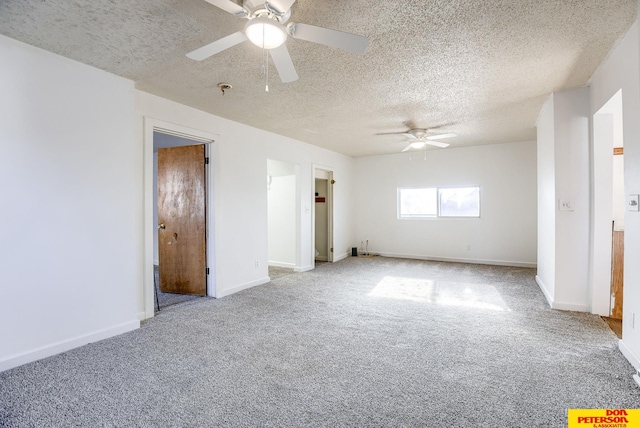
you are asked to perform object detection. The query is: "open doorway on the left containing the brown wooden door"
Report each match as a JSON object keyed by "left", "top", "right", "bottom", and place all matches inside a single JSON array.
[{"left": 153, "top": 131, "right": 208, "bottom": 311}]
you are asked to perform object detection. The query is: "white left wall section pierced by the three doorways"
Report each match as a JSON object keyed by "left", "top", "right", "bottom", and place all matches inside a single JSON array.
[{"left": 135, "top": 91, "right": 353, "bottom": 302}]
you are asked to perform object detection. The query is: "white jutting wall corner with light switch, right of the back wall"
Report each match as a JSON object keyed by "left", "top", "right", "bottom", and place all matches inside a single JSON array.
[{"left": 536, "top": 88, "right": 591, "bottom": 311}]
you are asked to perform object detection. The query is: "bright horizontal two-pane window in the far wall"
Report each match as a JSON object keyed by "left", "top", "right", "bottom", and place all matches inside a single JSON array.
[{"left": 398, "top": 186, "right": 480, "bottom": 219}]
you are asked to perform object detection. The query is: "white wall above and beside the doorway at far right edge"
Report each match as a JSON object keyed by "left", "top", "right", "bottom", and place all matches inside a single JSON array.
[{"left": 590, "top": 16, "right": 640, "bottom": 369}]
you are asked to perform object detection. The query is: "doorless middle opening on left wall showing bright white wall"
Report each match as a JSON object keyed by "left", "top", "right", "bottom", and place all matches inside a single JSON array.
[{"left": 267, "top": 159, "right": 298, "bottom": 280}]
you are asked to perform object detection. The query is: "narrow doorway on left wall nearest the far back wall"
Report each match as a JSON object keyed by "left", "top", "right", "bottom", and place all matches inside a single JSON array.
[{"left": 313, "top": 168, "right": 335, "bottom": 263}]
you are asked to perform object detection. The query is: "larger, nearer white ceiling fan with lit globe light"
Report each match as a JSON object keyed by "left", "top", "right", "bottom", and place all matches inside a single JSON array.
[{"left": 187, "top": 0, "right": 369, "bottom": 83}]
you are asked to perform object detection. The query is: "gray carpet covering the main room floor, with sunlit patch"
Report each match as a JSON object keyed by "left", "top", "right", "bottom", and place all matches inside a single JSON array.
[{"left": 0, "top": 257, "right": 640, "bottom": 427}]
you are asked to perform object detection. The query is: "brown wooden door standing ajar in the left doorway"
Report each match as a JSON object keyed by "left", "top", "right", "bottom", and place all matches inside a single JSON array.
[{"left": 158, "top": 145, "right": 207, "bottom": 296}]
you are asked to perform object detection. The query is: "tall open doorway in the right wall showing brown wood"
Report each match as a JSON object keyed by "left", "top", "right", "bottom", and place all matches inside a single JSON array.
[{"left": 591, "top": 90, "right": 625, "bottom": 334}]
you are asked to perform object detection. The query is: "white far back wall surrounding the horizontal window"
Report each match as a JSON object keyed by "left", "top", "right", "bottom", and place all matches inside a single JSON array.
[{"left": 351, "top": 141, "right": 537, "bottom": 266}]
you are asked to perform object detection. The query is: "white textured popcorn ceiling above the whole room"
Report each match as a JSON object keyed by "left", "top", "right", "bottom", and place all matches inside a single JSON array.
[{"left": 0, "top": 0, "right": 637, "bottom": 156}]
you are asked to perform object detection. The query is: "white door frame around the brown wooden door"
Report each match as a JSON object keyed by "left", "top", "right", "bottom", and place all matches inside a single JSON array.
[{"left": 143, "top": 117, "right": 220, "bottom": 319}]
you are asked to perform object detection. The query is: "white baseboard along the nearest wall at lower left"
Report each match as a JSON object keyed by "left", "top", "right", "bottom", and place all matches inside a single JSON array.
[{"left": 0, "top": 320, "right": 140, "bottom": 372}]
